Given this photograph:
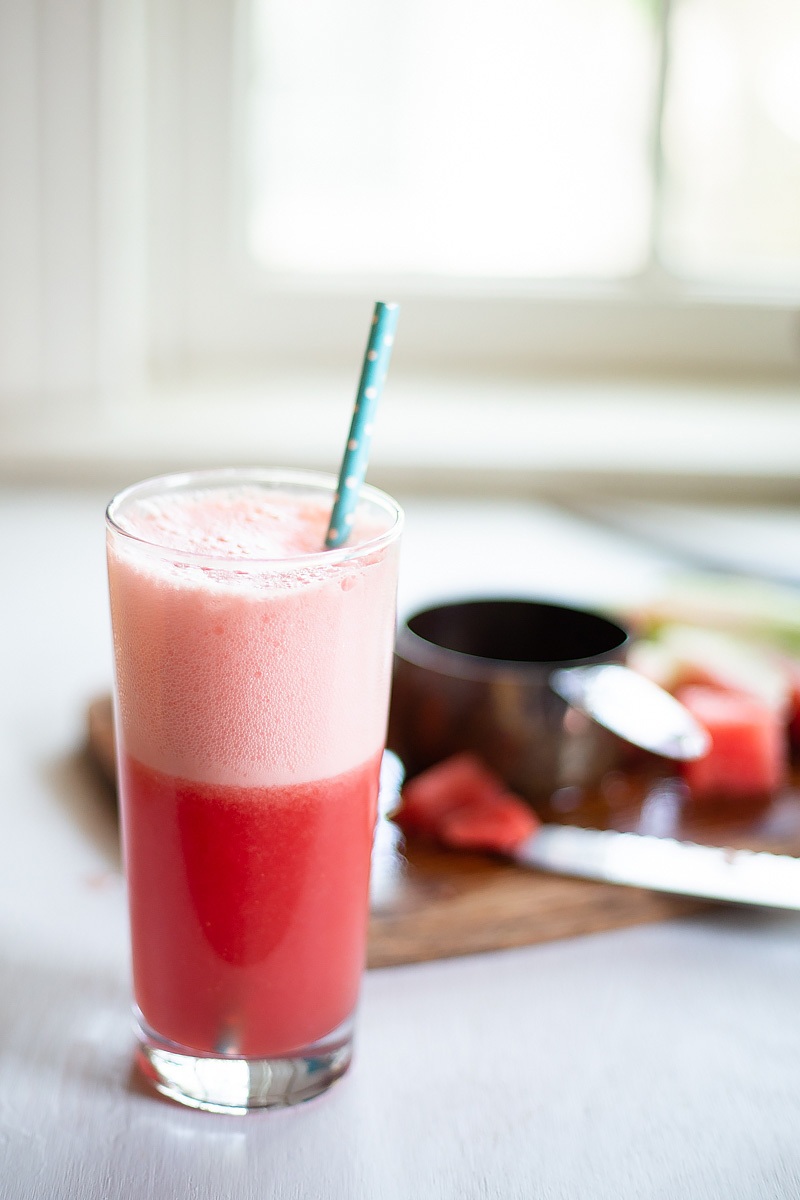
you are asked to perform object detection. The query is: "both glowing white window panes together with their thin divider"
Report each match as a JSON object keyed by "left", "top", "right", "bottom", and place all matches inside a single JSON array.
[{"left": 247, "top": 0, "right": 800, "bottom": 286}]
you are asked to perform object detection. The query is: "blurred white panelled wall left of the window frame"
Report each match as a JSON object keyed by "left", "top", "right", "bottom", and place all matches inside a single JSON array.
[{"left": 0, "top": 0, "right": 145, "bottom": 412}]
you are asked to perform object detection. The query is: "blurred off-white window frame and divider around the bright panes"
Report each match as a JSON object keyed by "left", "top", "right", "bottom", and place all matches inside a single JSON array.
[{"left": 142, "top": 0, "right": 800, "bottom": 377}]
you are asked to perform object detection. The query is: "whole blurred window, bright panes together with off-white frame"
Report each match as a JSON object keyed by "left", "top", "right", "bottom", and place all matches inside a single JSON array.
[{"left": 143, "top": 0, "right": 800, "bottom": 376}]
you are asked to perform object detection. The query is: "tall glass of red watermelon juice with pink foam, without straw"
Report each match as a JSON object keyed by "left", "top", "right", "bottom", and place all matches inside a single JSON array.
[{"left": 108, "top": 470, "right": 402, "bottom": 1111}]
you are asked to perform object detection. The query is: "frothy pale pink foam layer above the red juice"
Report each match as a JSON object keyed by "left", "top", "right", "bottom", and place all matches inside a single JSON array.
[{"left": 109, "top": 488, "right": 396, "bottom": 786}]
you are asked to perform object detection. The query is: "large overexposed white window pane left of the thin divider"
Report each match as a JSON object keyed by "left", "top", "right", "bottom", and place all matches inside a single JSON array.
[{"left": 248, "top": 0, "right": 656, "bottom": 277}]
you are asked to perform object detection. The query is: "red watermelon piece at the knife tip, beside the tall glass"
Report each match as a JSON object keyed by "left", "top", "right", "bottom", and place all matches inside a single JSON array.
[{"left": 398, "top": 754, "right": 540, "bottom": 853}]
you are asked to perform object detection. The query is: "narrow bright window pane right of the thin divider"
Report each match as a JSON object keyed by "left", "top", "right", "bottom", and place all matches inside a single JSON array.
[{"left": 663, "top": 0, "right": 800, "bottom": 283}]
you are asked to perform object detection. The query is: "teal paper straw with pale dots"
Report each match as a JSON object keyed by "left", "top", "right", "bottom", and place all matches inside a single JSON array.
[{"left": 325, "top": 300, "right": 399, "bottom": 550}]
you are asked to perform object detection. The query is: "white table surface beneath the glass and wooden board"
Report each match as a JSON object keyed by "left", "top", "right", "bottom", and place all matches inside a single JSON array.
[{"left": 0, "top": 490, "right": 800, "bottom": 1200}]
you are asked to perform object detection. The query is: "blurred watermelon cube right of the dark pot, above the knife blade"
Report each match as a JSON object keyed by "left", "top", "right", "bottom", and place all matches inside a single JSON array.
[{"left": 676, "top": 686, "right": 788, "bottom": 799}]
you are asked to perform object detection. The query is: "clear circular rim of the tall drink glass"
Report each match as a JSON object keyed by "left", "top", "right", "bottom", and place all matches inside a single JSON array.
[{"left": 106, "top": 467, "right": 405, "bottom": 572}]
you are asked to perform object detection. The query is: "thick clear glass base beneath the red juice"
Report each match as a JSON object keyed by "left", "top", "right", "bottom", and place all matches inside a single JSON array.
[{"left": 137, "top": 1019, "right": 353, "bottom": 1115}]
